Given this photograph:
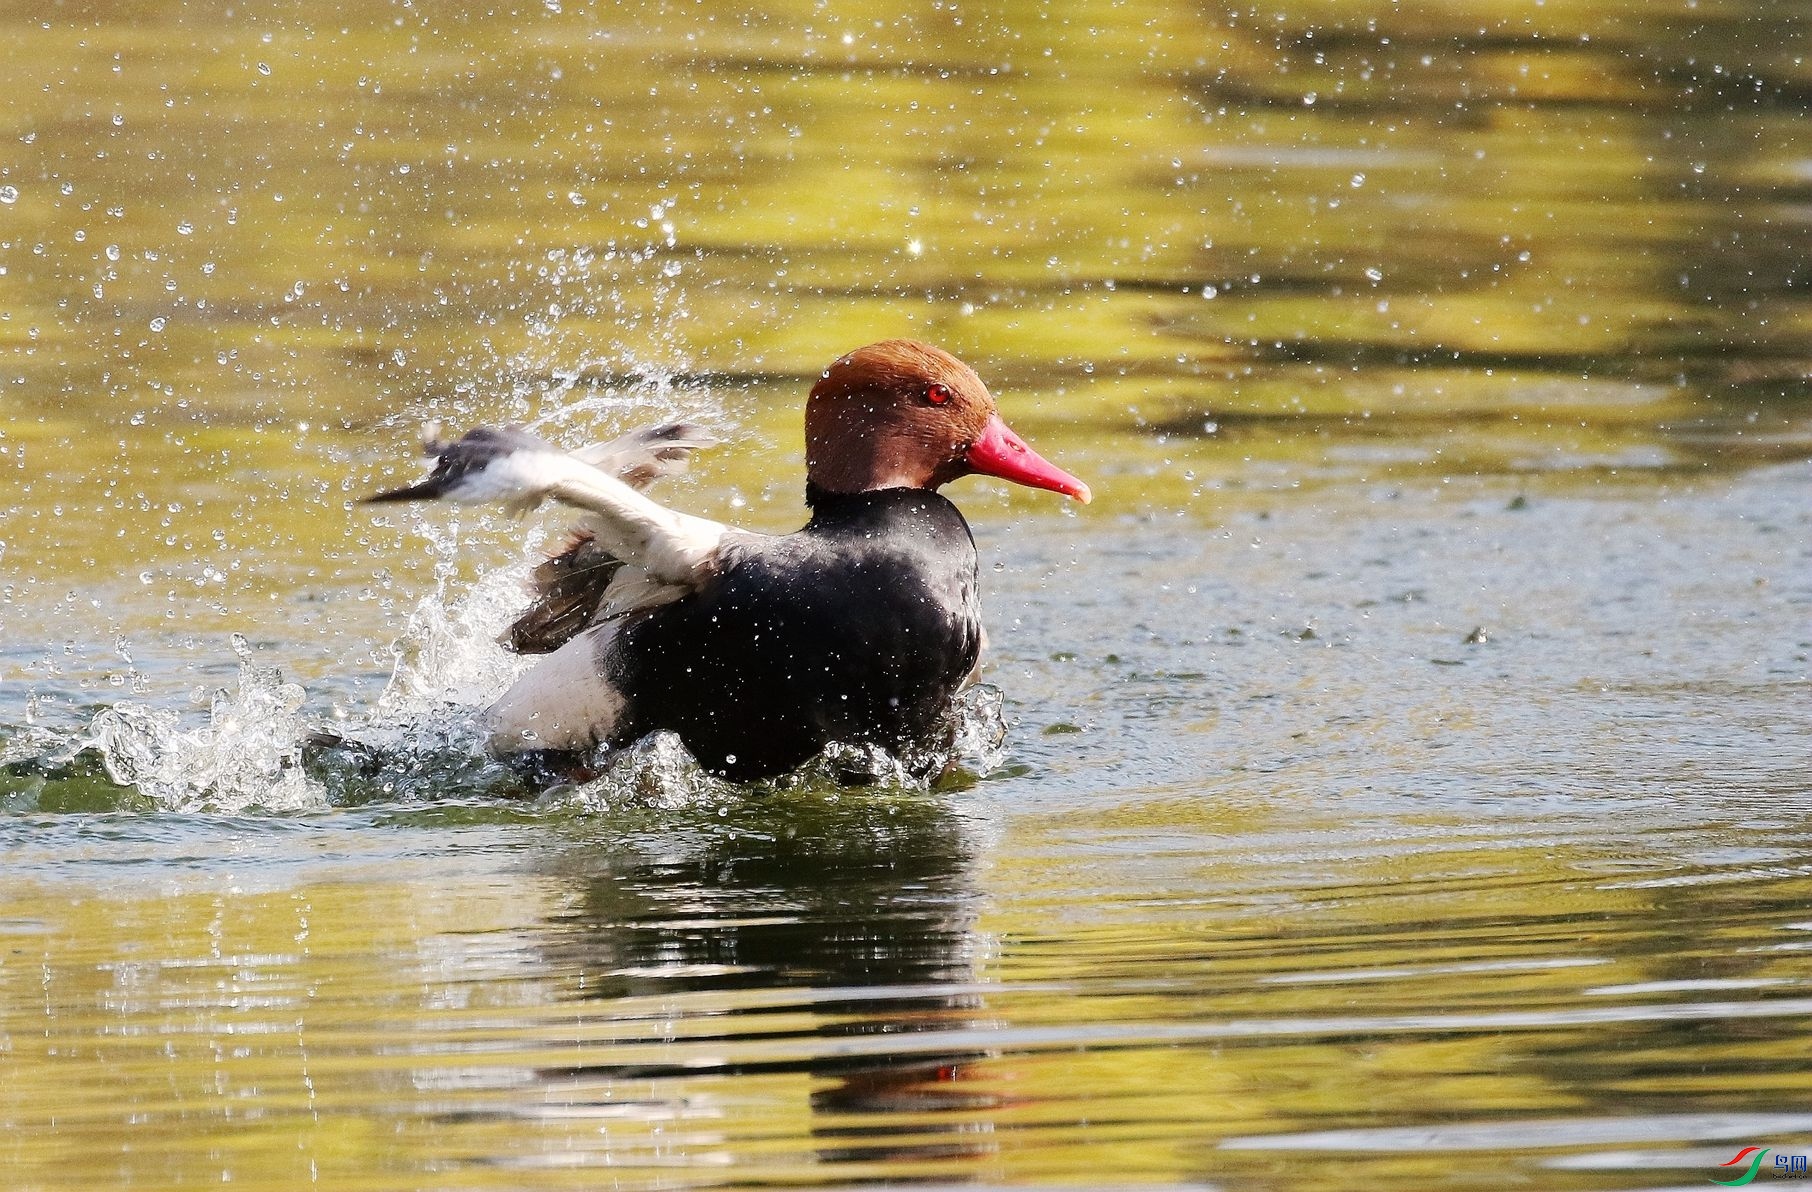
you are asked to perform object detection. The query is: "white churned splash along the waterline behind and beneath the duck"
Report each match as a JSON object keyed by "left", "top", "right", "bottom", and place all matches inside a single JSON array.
[{"left": 14, "top": 499, "right": 1006, "bottom": 812}]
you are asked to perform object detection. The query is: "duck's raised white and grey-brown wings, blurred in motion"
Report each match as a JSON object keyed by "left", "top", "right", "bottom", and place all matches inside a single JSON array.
[{"left": 366, "top": 422, "right": 743, "bottom": 654}]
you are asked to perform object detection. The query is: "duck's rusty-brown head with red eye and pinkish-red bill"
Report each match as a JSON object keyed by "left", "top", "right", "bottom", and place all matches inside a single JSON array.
[{"left": 805, "top": 339, "right": 1089, "bottom": 504}]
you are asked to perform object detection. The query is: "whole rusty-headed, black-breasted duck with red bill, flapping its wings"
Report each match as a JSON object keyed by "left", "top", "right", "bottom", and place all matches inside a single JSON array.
[{"left": 368, "top": 339, "right": 1089, "bottom": 781}]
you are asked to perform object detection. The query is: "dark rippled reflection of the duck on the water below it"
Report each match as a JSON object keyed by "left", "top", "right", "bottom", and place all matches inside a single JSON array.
[{"left": 521, "top": 792, "right": 1000, "bottom": 1168}]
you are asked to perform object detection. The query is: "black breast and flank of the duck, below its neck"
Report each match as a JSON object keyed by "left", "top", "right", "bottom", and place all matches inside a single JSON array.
[{"left": 603, "top": 489, "right": 982, "bottom": 779}]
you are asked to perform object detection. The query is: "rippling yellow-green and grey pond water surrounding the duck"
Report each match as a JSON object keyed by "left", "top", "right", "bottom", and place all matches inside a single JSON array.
[{"left": 0, "top": 0, "right": 1812, "bottom": 1188}]
